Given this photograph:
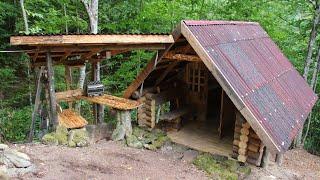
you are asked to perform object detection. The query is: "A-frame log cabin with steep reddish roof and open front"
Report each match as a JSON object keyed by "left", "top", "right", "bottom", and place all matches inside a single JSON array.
[{"left": 124, "top": 21, "right": 317, "bottom": 165}]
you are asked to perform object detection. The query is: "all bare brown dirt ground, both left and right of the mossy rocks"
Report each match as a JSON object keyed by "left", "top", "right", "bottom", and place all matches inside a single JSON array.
[{"left": 11, "top": 141, "right": 320, "bottom": 180}]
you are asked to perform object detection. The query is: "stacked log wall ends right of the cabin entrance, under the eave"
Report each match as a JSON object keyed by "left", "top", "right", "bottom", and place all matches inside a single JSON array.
[{"left": 232, "top": 112, "right": 264, "bottom": 166}]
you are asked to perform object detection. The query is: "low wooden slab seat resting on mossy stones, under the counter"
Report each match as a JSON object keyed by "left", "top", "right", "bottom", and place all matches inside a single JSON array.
[{"left": 58, "top": 109, "right": 88, "bottom": 129}]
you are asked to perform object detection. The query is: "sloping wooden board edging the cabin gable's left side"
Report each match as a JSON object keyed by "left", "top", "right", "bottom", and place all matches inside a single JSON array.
[{"left": 123, "top": 25, "right": 181, "bottom": 98}]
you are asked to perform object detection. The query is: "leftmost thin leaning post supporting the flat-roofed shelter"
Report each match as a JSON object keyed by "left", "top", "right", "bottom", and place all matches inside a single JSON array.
[{"left": 28, "top": 66, "right": 44, "bottom": 142}]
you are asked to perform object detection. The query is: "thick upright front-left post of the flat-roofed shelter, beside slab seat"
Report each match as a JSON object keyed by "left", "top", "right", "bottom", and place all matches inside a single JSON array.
[{"left": 47, "top": 51, "right": 58, "bottom": 130}]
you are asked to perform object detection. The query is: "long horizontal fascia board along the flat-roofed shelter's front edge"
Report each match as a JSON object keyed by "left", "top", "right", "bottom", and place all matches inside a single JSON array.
[{"left": 10, "top": 34, "right": 174, "bottom": 46}]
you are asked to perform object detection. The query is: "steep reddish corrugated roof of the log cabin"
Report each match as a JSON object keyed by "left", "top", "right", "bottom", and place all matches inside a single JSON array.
[{"left": 184, "top": 21, "right": 317, "bottom": 151}]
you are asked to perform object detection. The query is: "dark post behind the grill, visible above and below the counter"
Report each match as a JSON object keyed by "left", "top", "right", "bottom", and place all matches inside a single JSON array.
[{"left": 92, "top": 62, "right": 104, "bottom": 123}]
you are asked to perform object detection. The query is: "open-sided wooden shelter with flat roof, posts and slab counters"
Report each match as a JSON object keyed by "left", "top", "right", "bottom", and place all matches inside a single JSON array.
[{"left": 10, "top": 34, "right": 174, "bottom": 136}]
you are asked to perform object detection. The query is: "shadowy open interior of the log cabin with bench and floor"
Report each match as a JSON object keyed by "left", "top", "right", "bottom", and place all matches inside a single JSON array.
[{"left": 138, "top": 40, "right": 235, "bottom": 155}]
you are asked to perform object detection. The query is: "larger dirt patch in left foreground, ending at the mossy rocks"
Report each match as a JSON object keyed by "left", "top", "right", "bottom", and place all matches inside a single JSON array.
[{"left": 13, "top": 141, "right": 207, "bottom": 179}]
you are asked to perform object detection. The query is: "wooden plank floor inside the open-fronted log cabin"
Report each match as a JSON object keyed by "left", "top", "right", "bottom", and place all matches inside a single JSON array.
[{"left": 168, "top": 122, "right": 233, "bottom": 157}]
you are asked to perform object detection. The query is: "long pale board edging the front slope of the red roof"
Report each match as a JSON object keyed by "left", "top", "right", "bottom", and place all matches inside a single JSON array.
[{"left": 181, "top": 21, "right": 281, "bottom": 152}]
